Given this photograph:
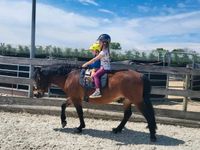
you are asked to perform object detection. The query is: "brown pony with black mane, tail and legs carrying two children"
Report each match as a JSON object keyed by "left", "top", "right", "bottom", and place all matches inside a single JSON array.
[{"left": 32, "top": 64, "right": 157, "bottom": 142}]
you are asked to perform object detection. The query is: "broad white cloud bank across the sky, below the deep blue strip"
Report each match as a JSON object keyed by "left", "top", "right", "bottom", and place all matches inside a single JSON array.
[{"left": 0, "top": 0, "right": 200, "bottom": 52}]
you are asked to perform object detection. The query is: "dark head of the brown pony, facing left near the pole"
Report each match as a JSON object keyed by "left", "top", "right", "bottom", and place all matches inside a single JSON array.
[{"left": 32, "top": 67, "right": 49, "bottom": 98}]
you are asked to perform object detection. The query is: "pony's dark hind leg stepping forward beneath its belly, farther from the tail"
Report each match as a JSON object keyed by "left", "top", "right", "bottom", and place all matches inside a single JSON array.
[{"left": 112, "top": 104, "right": 132, "bottom": 133}]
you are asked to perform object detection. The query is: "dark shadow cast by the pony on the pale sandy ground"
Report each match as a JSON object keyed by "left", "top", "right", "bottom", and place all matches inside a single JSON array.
[{"left": 54, "top": 128, "right": 185, "bottom": 146}]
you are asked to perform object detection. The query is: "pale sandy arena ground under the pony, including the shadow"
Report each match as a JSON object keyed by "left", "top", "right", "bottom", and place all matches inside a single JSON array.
[{"left": 0, "top": 112, "right": 200, "bottom": 150}]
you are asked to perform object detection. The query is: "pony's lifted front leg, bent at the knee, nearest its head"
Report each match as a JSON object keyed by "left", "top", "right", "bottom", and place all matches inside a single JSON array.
[{"left": 60, "top": 98, "right": 72, "bottom": 128}]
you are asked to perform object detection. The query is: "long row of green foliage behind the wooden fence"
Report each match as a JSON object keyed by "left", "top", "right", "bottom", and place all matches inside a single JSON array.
[{"left": 0, "top": 42, "right": 200, "bottom": 66}]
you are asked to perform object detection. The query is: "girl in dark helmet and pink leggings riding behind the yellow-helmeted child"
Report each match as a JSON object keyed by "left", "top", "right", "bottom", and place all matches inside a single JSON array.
[{"left": 82, "top": 34, "right": 111, "bottom": 98}]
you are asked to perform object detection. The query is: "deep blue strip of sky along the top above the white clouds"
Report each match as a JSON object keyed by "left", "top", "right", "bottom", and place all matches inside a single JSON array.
[{"left": 40, "top": 0, "right": 200, "bottom": 19}]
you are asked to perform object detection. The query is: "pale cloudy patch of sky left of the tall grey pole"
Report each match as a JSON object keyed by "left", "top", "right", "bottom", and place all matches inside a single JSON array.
[{"left": 0, "top": 0, "right": 31, "bottom": 44}]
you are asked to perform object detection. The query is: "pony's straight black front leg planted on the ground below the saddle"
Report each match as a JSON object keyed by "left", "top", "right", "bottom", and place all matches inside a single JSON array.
[{"left": 74, "top": 104, "right": 85, "bottom": 133}]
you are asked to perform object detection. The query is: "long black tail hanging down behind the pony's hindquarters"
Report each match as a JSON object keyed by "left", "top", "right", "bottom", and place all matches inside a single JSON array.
[{"left": 142, "top": 75, "right": 157, "bottom": 129}]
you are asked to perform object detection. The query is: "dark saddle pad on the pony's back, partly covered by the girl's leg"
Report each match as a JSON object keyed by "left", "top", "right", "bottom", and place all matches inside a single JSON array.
[{"left": 79, "top": 69, "right": 108, "bottom": 89}]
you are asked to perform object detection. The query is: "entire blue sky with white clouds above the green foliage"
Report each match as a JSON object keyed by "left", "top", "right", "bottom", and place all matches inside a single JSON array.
[{"left": 0, "top": 0, "right": 200, "bottom": 52}]
